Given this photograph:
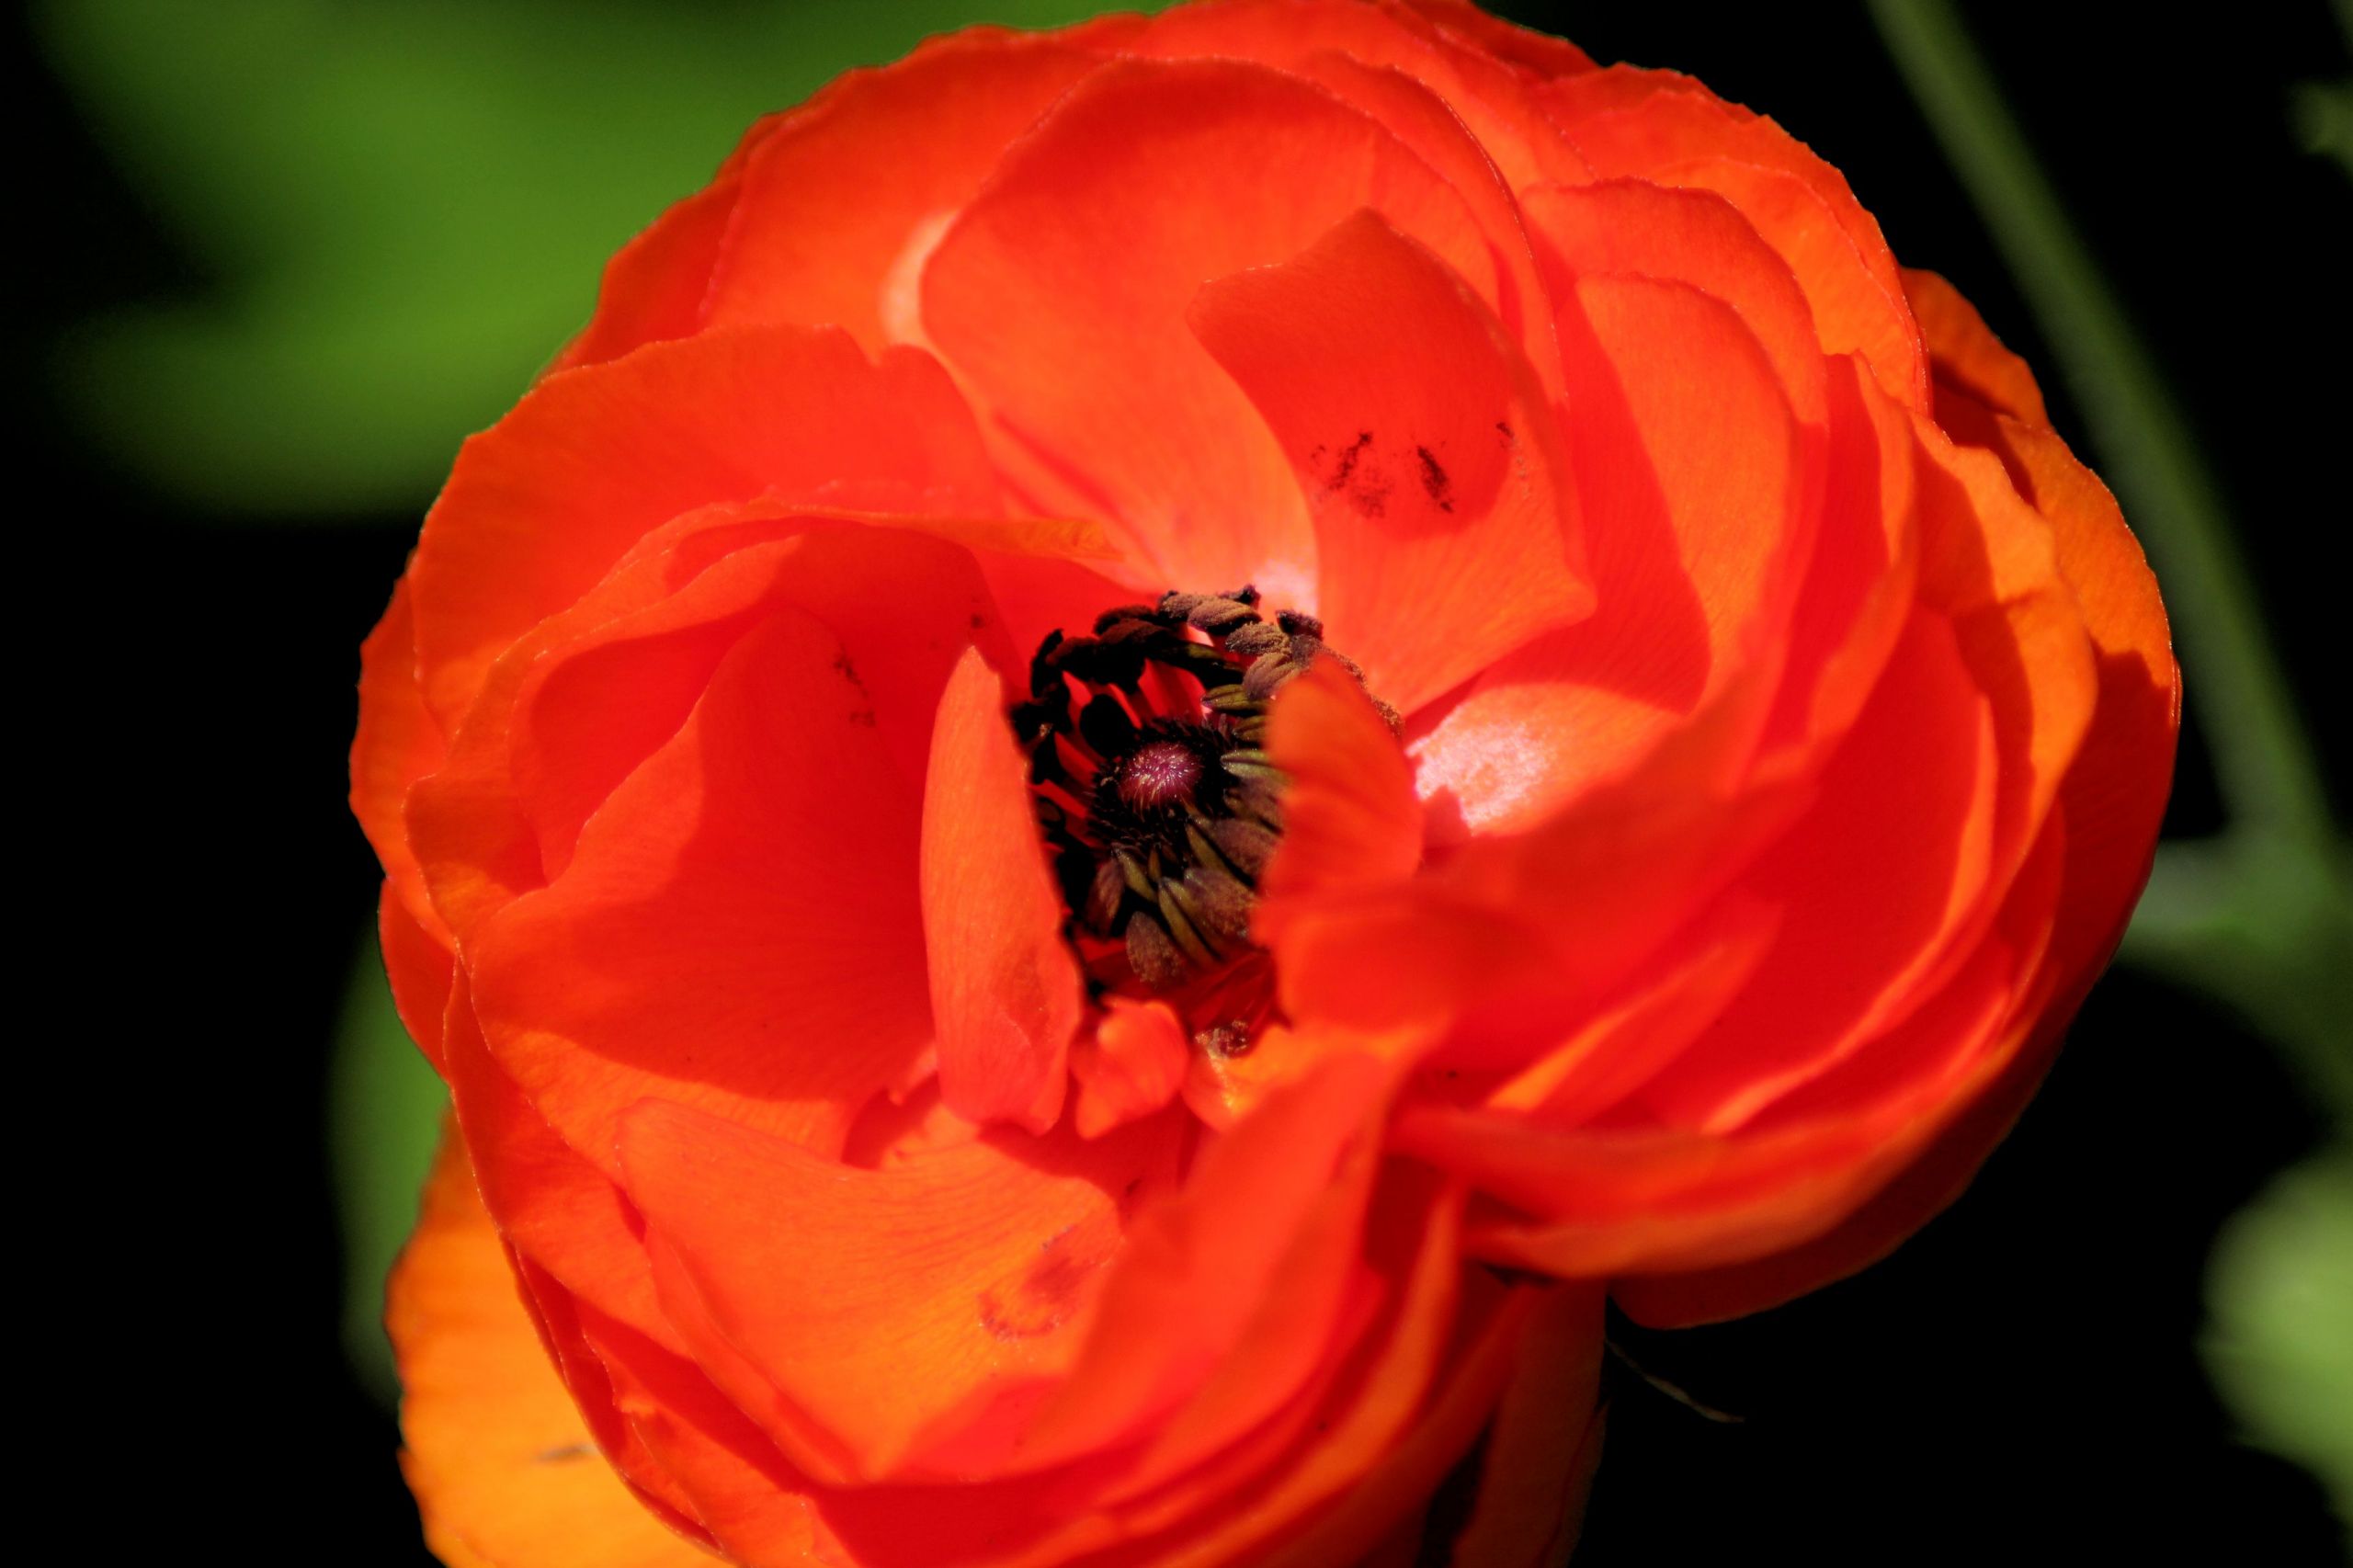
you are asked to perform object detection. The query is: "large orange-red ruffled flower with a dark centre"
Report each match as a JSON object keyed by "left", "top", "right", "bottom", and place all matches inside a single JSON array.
[{"left": 353, "top": 0, "right": 2177, "bottom": 1568}]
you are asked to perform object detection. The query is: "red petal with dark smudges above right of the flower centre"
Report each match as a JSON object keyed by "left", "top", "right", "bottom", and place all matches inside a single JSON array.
[{"left": 1186, "top": 212, "right": 1593, "bottom": 713}]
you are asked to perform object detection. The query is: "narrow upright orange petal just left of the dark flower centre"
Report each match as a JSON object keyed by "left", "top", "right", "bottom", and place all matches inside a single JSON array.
[{"left": 923, "top": 647, "right": 1083, "bottom": 1132}]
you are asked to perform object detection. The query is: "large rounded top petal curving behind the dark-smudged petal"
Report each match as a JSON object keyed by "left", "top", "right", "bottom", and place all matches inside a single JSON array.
[{"left": 923, "top": 59, "right": 1495, "bottom": 600}]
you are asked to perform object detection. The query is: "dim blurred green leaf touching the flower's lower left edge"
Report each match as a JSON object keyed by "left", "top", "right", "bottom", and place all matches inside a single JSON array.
[{"left": 327, "top": 937, "right": 449, "bottom": 1403}]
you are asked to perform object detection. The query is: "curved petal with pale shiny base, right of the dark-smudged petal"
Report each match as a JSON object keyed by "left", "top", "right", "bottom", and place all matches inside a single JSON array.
[{"left": 1415, "top": 276, "right": 1814, "bottom": 838}]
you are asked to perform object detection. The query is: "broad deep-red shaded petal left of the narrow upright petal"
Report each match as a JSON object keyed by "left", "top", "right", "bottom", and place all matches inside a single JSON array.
[{"left": 471, "top": 609, "right": 932, "bottom": 1177}]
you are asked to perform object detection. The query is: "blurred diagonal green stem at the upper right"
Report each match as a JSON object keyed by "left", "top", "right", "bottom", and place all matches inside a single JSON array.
[{"left": 1869, "top": 0, "right": 2335, "bottom": 847}]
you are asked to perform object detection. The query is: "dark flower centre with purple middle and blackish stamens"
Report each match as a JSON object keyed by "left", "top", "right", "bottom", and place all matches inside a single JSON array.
[{"left": 1012, "top": 586, "right": 1395, "bottom": 1055}]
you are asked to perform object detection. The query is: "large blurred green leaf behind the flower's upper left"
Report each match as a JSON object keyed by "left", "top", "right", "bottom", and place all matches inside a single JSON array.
[{"left": 40, "top": 0, "right": 1139, "bottom": 516}]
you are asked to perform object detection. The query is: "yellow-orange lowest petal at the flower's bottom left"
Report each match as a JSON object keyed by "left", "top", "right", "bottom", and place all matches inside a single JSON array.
[{"left": 386, "top": 1137, "right": 710, "bottom": 1568}]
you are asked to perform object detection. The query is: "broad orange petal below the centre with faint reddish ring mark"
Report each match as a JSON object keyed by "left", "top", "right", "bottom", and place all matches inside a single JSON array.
[{"left": 621, "top": 1099, "right": 1176, "bottom": 1479}]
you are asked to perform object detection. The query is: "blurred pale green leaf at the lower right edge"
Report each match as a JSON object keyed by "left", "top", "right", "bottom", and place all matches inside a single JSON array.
[{"left": 2205, "top": 1146, "right": 2353, "bottom": 1528}]
